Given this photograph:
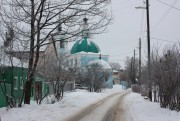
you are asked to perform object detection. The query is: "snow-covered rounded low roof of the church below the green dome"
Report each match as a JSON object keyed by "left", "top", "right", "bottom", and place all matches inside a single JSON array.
[{"left": 88, "top": 59, "right": 112, "bottom": 69}]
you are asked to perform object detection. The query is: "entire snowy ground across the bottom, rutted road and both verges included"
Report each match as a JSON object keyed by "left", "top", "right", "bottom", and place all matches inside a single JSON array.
[{"left": 0, "top": 85, "right": 180, "bottom": 121}]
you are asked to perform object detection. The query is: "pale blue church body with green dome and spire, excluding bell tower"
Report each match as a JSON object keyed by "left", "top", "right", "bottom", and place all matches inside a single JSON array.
[{"left": 69, "top": 18, "right": 113, "bottom": 88}]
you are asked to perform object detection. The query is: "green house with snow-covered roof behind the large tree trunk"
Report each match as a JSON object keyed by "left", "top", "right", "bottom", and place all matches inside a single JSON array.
[{"left": 0, "top": 51, "right": 48, "bottom": 107}]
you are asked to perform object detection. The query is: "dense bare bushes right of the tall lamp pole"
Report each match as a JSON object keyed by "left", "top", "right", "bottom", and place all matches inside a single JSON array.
[{"left": 146, "top": 46, "right": 180, "bottom": 110}]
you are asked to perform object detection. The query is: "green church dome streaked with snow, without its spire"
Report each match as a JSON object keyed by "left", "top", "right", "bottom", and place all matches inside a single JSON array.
[{"left": 71, "top": 37, "right": 100, "bottom": 54}]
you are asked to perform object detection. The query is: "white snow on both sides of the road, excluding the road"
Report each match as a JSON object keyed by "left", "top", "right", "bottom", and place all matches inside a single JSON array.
[{"left": 0, "top": 85, "right": 180, "bottom": 121}]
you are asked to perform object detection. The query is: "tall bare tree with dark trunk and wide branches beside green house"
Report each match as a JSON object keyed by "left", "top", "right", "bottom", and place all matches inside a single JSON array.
[{"left": 0, "top": 0, "right": 111, "bottom": 104}]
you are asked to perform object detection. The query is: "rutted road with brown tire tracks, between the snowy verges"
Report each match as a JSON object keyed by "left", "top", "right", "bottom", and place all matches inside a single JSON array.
[{"left": 66, "top": 90, "right": 130, "bottom": 121}]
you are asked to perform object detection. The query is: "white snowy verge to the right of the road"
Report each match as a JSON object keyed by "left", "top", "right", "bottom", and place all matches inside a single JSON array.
[{"left": 125, "top": 93, "right": 180, "bottom": 121}]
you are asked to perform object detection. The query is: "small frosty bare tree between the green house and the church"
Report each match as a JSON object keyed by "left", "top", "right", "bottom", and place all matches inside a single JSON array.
[{"left": 37, "top": 51, "right": 78, "bottom": 104}]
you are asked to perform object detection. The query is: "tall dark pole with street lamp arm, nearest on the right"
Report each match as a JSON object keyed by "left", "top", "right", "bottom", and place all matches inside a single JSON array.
[{"left": 135, "top": 0, "right": 152, "bottom": 101}]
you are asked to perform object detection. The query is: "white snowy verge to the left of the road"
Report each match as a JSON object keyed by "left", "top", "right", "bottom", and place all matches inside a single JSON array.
[{"left": 0, "top": 85, "right": 122, "bottom": 121}]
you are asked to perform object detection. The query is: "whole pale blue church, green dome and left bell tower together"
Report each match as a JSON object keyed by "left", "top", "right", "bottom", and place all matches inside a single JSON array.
[{"left": 41, "top": 18, "right": 113, "bottom": 91}]
